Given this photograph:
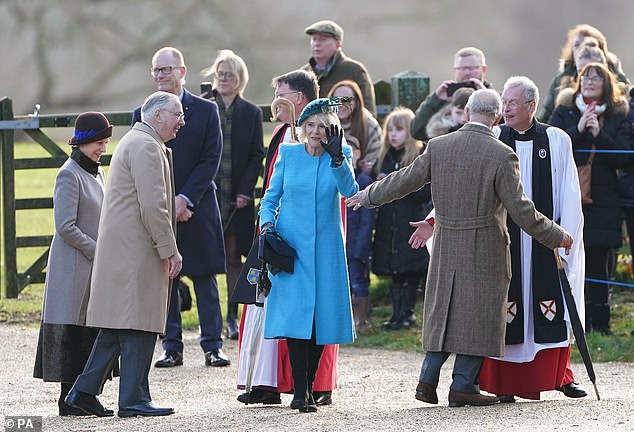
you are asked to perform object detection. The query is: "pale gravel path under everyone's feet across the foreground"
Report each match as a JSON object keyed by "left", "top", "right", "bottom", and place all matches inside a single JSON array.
[{"left": 0, "top": 325, "right": 634, "bottom": 432}]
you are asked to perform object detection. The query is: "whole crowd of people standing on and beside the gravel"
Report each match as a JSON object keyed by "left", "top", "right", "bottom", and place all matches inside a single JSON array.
[{"left": 34, "top": 20, "right": 634, "bottom": 417}]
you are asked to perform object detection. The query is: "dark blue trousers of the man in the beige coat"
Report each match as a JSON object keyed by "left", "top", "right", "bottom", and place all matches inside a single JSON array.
[{"left": 73, "top": 329, "right": 156, "bottom": 408}]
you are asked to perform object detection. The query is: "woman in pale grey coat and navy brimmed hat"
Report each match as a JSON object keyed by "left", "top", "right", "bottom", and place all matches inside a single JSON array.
[{"left": 33, "top": 112, "right": 112, "bottom": 416}]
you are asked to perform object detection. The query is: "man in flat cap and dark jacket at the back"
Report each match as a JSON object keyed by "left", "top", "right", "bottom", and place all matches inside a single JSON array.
[{"left": 302, "top": 20, "right": 376, "bottom": 114}]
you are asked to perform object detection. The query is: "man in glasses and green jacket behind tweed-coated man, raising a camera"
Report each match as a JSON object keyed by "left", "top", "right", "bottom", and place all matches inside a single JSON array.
[{"left": 410, "top": 47, "right": 491, "bottom": 140}]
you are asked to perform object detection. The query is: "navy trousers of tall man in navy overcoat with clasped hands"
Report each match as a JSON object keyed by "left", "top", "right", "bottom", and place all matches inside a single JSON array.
[{"left": 162, "top": 275, "right": 222, "bottom": 352}]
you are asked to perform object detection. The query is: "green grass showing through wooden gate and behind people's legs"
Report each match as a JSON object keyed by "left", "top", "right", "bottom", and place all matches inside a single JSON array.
[{"left": 0, "top": 139, "right": 634, "bottom": 362}]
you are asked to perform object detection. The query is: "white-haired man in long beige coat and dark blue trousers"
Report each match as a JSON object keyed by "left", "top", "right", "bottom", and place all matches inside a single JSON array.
[{"left": 65, "top": 92, "right": 184, "bottom": 417}]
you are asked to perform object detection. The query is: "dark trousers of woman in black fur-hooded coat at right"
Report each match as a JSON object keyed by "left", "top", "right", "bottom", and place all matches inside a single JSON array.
[{"left": 585, "top": 246, "right": 611, "bottom": 331}]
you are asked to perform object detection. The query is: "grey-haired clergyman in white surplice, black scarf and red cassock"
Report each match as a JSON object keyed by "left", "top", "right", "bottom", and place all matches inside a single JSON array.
[{"left": 480, "top": 76, "right": 587, "bottom": 402}]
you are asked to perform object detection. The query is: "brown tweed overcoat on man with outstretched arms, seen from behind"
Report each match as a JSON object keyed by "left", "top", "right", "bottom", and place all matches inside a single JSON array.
[{"left": 363, "top": 123, "right": 563, "bottom": 357}]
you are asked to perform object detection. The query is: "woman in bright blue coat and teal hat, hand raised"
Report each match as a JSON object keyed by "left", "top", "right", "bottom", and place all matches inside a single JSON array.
[{"left": 260, "top": 98, "right": 358, "bottom": 412}]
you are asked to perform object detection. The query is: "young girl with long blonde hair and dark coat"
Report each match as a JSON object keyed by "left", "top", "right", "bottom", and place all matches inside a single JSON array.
[{"left": 372, "top": 107, "right": 431, "bottom": 330}]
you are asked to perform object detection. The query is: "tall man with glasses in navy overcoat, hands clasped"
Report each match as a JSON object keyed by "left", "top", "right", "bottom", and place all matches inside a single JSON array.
[{"left": 133, "top": 47, "right": 230, "bottom": 367}]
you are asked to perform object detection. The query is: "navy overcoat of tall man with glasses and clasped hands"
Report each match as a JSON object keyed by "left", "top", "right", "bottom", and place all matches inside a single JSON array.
[{"left": 132, "top": 90, "right": 225, "bottom": 276}]
